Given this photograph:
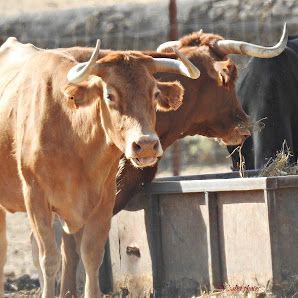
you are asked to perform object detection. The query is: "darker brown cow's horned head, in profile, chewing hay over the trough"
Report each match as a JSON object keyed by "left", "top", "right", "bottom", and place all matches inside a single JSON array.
[{"left": 157, "top": 26, "right": 287, "bottom": 145}]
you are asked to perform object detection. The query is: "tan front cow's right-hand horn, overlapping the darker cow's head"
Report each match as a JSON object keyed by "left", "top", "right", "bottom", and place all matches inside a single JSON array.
[{"left": 154, "top": 48, "right": 200, "bottom": 79}]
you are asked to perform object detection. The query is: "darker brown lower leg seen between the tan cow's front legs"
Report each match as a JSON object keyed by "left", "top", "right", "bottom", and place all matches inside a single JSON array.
[{"left": 60, "top": 231, "right": 81, "bottom": 298}]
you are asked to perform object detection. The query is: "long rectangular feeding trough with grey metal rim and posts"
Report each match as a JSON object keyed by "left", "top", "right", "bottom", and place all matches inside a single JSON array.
[{"left": 101, "top": 171, "right": 298, "bottom": 297}]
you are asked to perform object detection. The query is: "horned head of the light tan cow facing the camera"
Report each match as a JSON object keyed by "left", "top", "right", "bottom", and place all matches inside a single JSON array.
[{"left": 63, "top": 44, "right": 199, "bottom": 167}]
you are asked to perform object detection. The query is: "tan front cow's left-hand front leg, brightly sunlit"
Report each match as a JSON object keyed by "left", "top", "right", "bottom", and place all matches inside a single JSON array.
[{"left": 23, "top": 183, "right": 61, "bottom": 298}]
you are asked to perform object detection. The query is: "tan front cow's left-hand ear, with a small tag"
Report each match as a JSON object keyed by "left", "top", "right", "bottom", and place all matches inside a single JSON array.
[{"left": 61, "top": 80, "right": 102, "bottom": 111}]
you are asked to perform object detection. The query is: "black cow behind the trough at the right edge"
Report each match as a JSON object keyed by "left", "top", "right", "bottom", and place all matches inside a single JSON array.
[{"left": 228, "top": 36, "right": 298, "bottom": 170}]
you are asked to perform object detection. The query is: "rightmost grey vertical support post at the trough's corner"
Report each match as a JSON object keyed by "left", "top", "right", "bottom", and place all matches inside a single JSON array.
[{"left": 264, "top": 187, "right": 281, "bottom": 284}]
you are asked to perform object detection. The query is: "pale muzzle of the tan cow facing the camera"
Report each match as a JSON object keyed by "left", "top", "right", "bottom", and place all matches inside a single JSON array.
[{"left": 126, "top": 134, "right": 163, "bottom": 168}]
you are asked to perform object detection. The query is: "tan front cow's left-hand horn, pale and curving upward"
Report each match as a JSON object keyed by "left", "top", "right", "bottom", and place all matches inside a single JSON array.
[{"left": 67, "top": 39, "right": 100, "bottom": 83}]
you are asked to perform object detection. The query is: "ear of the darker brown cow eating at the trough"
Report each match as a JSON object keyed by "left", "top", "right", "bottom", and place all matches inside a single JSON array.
[{"left": 213, "top": 59, "right": 237, "bottom": 89}]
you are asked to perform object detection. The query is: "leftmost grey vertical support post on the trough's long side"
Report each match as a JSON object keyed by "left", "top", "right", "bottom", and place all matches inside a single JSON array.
[{"left": 147, "top": 194, "right": 164, "bottom": 297}]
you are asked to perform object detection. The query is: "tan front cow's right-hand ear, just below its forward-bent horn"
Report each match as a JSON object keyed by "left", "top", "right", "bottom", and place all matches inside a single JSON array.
[{"left": 157, "top": 81, "right": 184, "bottom": 111}]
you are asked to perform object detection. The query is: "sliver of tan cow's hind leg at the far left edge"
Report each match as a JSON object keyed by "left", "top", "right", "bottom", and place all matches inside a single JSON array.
[{"left": 0, "top": 208, "right": 7, "bottom": 298}]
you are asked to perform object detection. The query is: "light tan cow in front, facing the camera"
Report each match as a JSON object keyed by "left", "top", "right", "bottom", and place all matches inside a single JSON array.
[{"left": 0, "top": 38, "right": 199, "bottom": 298}]
